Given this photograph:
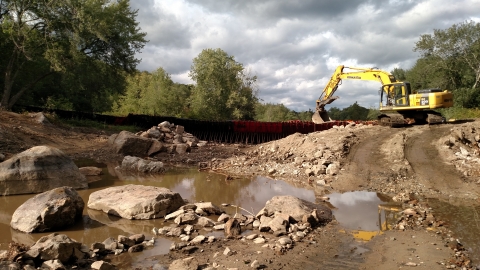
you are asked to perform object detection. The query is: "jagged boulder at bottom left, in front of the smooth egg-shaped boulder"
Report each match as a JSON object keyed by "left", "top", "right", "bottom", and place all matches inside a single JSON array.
[{"left": 24, "top": 233, "right": 86, "bottom": 263}]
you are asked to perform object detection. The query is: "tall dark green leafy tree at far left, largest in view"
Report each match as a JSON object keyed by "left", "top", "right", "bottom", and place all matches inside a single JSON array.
[{"left": 0, "top": 0, "right": 146, "bottom": 109}]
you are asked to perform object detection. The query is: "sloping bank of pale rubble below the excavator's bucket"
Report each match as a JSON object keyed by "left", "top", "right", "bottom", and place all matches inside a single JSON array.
[{"left": 214, "top": 123, "right": 371, "bottom": 185}]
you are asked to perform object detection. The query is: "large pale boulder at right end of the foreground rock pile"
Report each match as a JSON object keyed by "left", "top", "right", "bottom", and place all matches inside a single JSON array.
[{"left": 263, "top": 195, "right": 332, "bottom": 223}]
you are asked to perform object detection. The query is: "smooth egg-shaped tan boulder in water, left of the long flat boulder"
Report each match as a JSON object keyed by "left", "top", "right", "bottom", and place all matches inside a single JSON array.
[{"left": 10, "top": 187, "right": 85, "bottom": 233}]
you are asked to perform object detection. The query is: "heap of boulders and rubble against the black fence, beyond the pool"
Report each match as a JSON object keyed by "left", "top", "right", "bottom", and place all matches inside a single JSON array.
[{"left": 108, "top": 121, "right": 206, "bottom": 157}]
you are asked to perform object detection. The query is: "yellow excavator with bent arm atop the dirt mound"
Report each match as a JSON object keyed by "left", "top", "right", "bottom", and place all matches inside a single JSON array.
[{"left": 312, "top": 65, "right": 453, "bottom": 127}]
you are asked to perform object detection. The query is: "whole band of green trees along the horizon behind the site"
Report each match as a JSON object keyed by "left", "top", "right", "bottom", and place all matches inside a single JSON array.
[{"left": 0, "top": 0, "right": 480, "bottom": 121}]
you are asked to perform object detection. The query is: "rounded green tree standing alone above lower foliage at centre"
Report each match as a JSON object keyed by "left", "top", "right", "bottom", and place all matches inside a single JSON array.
[{"left": 189, "top": 49, "right": 257, "bottom": 120}]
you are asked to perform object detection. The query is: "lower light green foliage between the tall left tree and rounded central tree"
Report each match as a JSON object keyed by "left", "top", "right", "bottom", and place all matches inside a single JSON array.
[{"left": 114, "top": 68, "right": 192, "bottom": 117}]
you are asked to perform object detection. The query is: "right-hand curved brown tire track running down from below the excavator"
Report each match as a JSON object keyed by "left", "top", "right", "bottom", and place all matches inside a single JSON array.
[{"left": 405, "top": 126, "right": 466, "bottom": 194}]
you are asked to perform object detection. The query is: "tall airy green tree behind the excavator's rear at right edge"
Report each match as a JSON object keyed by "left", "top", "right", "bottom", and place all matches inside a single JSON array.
[{"left": 414, "top": 21, "right": 480, "bottom": 89}]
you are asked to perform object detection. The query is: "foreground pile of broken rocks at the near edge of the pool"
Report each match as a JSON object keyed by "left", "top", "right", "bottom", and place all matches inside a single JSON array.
[{"left": 153, "top": 196, "right": 332, "bottom": 254}]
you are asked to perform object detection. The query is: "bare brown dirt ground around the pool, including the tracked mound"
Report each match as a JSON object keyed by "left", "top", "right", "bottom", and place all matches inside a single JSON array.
[{"left": 0, "top": 112, "right": 480, "bottom": 269}]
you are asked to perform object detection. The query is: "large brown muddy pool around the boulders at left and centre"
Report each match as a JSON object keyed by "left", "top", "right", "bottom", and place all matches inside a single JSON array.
[{"left": 0, "top": 161, "right": 315, "bottom": 257}]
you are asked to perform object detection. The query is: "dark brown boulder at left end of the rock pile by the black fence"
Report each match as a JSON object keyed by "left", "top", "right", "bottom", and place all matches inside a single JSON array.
[{"left": 109, "top": 130, "right": 153, "bottom": 157}]
